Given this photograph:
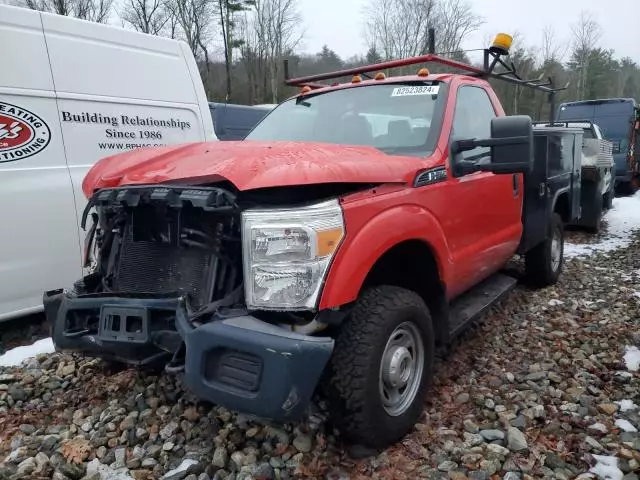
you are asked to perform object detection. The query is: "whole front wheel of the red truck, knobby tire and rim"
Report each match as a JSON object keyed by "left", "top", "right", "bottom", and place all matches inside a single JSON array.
[{"left": 326, "top": 286, "right": 435, "bottom": 448}]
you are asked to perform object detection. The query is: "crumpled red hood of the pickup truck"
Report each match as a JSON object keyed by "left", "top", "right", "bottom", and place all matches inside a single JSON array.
[{"left": 82, "top": 140, "right": 427, "bottom": 197}]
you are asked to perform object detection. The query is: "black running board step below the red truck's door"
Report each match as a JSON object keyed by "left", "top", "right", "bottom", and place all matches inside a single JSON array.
[{"left": 449, "top": 273, "right": 518, "bottom": 340}]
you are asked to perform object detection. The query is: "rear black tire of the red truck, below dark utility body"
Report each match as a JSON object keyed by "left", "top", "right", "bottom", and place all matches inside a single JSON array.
[{"left": 525, "top": 213, "right": 564, "bottom": 287}]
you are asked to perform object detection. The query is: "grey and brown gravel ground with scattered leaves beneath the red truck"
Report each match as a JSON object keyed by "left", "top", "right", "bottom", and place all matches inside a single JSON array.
[{"left": 0, "top": 230, "right": 640, "bottom": 480}]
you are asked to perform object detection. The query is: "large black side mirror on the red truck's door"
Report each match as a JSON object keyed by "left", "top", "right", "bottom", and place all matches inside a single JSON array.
[{"left": 450, "top": 115, "right": 533, "bottom": 176}]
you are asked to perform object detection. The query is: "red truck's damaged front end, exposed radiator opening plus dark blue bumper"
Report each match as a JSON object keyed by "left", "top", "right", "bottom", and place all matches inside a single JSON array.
[{"left": 44, "top": 185, "right": 333, "bottom": 421}]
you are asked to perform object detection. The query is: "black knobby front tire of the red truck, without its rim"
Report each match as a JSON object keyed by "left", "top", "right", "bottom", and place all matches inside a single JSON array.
[{"left": 325, "top": 286, "right": 435, "bottom": 449}]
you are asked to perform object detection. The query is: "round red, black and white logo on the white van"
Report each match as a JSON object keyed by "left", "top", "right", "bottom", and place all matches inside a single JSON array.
[{"left": 0, "top": 102, "right": 51, "bottom": 162}]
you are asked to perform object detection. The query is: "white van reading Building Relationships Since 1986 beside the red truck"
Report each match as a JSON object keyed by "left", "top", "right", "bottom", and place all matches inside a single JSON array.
[{"left": 0, "top": 5, "right": 217, "bottom": 321}]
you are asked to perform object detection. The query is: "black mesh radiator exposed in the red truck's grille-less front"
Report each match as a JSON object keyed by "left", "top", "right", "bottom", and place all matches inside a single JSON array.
[{"left": 113, "top": 226, "right": 213, "bottom": 305}]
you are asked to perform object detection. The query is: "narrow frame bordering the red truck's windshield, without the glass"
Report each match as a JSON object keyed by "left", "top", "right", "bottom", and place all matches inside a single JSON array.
[{"left": 243, "top": 79, "right": 450, "bottom": 158}]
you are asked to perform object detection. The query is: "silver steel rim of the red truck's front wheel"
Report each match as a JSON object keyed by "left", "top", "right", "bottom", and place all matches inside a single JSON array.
[{"left": 378, "top": 322, "right": 424, "bottom": 417}]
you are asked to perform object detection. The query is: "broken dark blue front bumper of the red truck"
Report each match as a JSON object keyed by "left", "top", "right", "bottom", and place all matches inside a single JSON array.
[{"left": 43, "top": 291, "right": 334, "bottom": 422}]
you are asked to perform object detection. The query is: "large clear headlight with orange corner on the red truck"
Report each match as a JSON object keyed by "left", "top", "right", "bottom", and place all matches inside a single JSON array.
[{"left": 242, "top": 200, "right": 344, "bottom": 310}]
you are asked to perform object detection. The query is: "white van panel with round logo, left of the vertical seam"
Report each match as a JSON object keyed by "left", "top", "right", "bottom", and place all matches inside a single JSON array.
[{"left": 0, "top": 5, "right": 82, "bottom": 320}]
